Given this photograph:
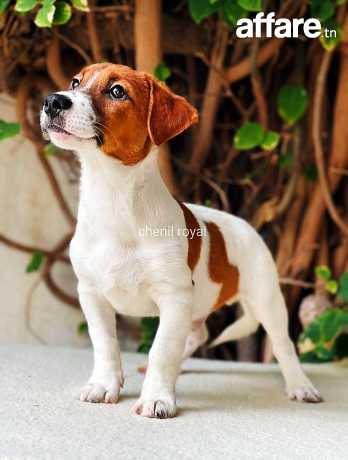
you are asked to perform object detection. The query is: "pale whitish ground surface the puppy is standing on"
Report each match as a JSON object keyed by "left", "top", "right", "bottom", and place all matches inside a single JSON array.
[{"left": 0, "top": 345, "right": 348, "bottom": 460}]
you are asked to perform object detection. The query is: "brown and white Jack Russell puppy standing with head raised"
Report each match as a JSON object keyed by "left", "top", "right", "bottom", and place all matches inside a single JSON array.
[{"left": 41, "top": 63, "right": 321, "bottom": 418}]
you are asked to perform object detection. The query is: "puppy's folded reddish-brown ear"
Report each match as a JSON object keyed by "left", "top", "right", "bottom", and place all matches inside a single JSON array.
[{"left": 147, "top": 75, "right": 198, "bottom": 145}]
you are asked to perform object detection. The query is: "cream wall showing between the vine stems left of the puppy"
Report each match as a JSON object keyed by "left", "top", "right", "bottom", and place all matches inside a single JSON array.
[{"left": 0, "top": 95, "right": 89, "bottom": 346}]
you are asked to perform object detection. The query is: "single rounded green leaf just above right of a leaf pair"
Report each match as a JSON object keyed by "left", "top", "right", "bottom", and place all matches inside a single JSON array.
[{"left": 278, "top": 85, "right": 308, "bottom": 125}]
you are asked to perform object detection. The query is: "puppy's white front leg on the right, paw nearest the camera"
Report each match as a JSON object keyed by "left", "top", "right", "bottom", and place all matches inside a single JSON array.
[{"left": 134, "top": 290, "right": 192, "bottom": 418}]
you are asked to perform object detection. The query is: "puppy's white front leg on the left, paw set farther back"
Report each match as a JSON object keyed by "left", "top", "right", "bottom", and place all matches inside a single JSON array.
[{"left": 78, "top": 285, "right": 123, "bottom": 403}]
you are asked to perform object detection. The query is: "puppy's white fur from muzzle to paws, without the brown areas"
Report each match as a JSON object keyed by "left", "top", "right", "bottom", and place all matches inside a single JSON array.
[{"left": 42, "top": 88, "right": 320, "bottom": 418}]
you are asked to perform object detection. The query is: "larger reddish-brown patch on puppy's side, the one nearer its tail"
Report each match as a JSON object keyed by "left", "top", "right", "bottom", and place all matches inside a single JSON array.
[{"left": 205, "top": 222, "right": 239, "bottom": 310}]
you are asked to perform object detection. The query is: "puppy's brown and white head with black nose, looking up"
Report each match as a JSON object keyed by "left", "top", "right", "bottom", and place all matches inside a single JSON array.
[{"left": 40, "top": 63, "right": 198, "bottom": 165}]
